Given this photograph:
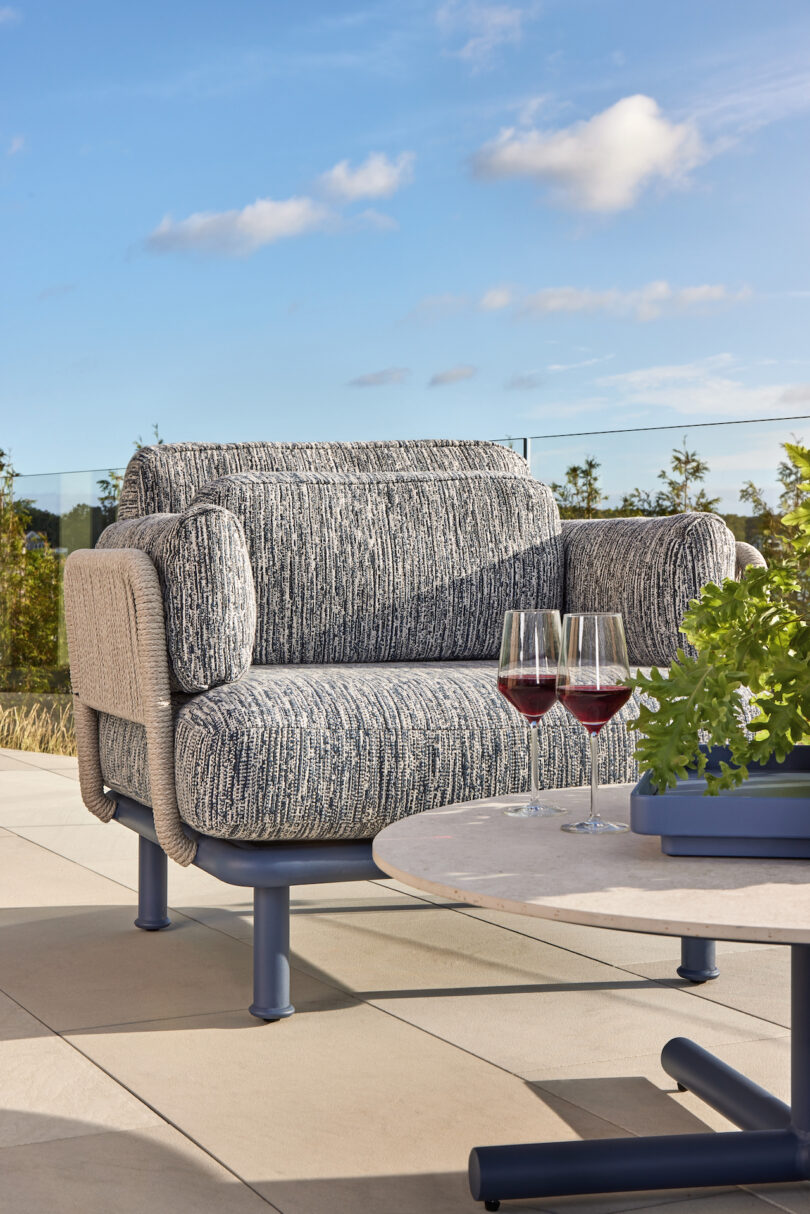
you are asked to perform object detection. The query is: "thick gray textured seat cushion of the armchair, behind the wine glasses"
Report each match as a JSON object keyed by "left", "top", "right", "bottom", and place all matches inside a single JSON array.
[{"left": 100, "top": 662, "right": 636, "bottom": 844}]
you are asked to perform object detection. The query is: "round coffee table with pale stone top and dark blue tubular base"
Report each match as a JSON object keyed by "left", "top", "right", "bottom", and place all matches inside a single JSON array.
[{"left": 374, "top": 785, "right": 810, "bottom": 1209}]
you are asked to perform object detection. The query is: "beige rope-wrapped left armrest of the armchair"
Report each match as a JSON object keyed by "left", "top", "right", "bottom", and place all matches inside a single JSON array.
[{"left": 64, "top": 549, "right": 197, "bottom": 864}]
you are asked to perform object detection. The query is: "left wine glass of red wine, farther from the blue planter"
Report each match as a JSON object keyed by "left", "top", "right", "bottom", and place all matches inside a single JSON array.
[{"left": 498, "top": 611, "right": 566, "bottom": 818}]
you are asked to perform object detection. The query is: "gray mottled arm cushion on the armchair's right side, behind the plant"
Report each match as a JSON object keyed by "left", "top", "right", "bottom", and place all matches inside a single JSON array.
[{"left": 562, "top": 514, "right": 735, "bottom": 665}]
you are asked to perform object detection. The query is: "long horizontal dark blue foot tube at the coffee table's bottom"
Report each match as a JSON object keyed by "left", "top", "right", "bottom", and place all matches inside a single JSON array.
[{"left": 470, "top": 1130, "right": 804, "bottom": 1202}]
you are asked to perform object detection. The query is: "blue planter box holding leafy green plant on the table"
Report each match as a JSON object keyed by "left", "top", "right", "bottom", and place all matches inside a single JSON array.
[{"left": 630, "top": 747, "right": 810, "bottom": 860}]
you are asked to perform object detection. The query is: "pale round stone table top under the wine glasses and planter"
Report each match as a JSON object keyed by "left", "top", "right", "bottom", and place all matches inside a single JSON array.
[{"left": 374, "top": 784, "right": 810, "bottom": 943}]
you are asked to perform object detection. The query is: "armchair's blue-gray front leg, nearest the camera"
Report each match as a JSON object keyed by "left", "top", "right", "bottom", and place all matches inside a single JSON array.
[{"left": 250, "top": 885, "right": 295, "bottom": 1020}]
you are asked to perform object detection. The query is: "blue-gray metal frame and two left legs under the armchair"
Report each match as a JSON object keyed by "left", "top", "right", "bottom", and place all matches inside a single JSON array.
[{"left": 115, "top": 796, "right": 387, "bottom": 1021}]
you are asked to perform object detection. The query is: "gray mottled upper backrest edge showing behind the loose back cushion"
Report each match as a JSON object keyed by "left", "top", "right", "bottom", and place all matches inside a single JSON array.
[{"left": 118, "top": 438, "right": 529, "bottom": 518}]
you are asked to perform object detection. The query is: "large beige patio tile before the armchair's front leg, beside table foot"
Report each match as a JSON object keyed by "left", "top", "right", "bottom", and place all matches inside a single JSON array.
[{"left": 69, "top": 1004, "right": 646, "bottom": 1214}]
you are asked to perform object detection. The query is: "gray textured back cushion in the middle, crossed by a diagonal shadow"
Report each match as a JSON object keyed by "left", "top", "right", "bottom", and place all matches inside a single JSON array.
[{"left": 190, "top": 472, "right": 562, "bottom": 664}]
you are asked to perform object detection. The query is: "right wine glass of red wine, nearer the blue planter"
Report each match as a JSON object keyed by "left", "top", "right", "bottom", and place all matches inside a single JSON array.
[{"left": 557, "top": 612, "right": 631, "bottom": 834}]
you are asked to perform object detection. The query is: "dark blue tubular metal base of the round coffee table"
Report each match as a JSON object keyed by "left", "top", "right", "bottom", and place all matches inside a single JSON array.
[{"left": 469, "top": 944, "right": 810, "bottom": 1210}]
